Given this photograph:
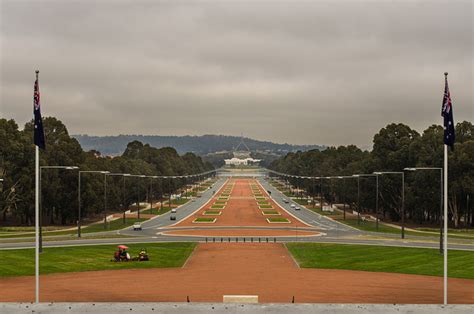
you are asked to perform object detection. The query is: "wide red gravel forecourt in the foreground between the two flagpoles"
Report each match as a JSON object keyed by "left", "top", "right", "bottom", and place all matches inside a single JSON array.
[{"left": 0, "top": 243, "right": 474, "bottom": 304}]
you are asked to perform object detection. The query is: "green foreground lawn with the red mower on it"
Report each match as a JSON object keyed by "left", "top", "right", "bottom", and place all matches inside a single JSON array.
[{"left": 0, "top": 242, "right": 196, "bottom": 277}]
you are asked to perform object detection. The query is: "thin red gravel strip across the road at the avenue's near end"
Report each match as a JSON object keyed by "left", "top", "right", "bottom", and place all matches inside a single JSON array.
[{"left": 162, "top": 229, "right": 320, "bottom": 237}]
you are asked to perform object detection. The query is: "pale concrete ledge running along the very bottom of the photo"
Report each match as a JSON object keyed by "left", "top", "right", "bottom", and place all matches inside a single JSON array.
[{"left": 0, "top": 298, "right": 472, "bottom": 314}]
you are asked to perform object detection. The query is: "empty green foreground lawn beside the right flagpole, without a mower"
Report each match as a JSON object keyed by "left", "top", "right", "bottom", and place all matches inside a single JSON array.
[{"left": 286, "top": 243, "right": 474, "bottom": 279}]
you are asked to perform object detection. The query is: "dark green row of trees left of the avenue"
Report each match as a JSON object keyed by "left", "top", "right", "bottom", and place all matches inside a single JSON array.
[{"left": 0, "top": 117, "right": 213, "bottom": 225}]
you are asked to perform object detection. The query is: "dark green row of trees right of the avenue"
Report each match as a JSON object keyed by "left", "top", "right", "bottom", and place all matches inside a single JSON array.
[{"left": 270, "top": 121, "right": 474, "bottom": 227}]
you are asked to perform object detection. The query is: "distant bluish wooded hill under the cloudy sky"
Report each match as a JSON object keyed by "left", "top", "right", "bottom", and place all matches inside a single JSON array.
[{"left": 72, "top": 135, "right": 325, "bottom": 156}]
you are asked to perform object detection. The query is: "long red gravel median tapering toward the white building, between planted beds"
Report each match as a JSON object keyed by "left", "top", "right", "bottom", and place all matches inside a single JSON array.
[{"left": 175, "top": 179, "right": 311, "bottom": 227}]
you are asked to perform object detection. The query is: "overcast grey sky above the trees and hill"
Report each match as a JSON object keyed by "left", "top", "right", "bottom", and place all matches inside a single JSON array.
[{"left": 0, "top": 0, "right": 474, "bottom": 146}]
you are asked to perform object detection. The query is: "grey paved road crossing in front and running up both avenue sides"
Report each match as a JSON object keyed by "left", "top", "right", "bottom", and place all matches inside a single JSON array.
[{"left": 0, "top": 178, "right": 474, "bottom": 250}]
